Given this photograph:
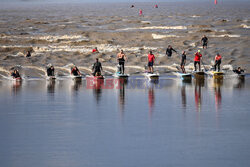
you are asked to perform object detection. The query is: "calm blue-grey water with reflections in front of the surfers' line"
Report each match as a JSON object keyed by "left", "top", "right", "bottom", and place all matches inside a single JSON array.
[{"left": 0, "top": 78, "right": 250, "bottom": 167}]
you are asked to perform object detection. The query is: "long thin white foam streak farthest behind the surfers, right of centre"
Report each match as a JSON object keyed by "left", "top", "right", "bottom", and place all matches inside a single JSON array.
[{"left": 120, "top": 26, "right": 187, "bottom": 31}]
